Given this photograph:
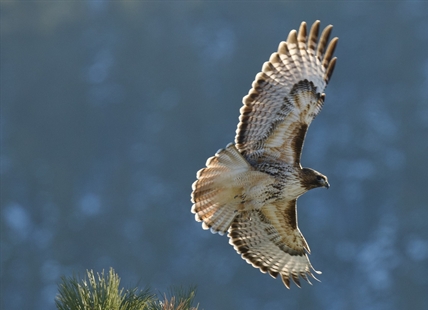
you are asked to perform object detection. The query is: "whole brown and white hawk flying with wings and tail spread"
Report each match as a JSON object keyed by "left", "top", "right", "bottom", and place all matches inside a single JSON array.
[{"left": 191, "top": 21, "right": 338, "bottom": 288}]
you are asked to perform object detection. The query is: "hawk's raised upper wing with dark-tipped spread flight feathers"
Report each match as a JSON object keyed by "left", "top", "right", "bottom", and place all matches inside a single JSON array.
[{"left": 235, "top": 21, "right": 338, "bottom": 165}]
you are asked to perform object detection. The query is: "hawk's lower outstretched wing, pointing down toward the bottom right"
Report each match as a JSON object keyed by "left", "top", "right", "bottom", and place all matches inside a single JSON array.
[{"left": 228, "top": 200, "right": 320, "bottom": 288}]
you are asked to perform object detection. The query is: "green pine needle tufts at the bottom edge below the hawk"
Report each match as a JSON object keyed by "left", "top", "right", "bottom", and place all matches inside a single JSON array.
[{"left": 55, "top": 268, "right": 198, "bottom": 310}]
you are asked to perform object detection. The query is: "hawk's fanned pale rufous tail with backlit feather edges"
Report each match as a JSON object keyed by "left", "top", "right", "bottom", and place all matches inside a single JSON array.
[{"left": 191, "top": 143, "right": 254, "bottom": 235}]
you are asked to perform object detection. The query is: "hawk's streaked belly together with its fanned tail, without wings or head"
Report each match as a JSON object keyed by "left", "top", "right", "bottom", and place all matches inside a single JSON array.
[{"left": 192, "top": 144, "right": 306, "bottom": 233}]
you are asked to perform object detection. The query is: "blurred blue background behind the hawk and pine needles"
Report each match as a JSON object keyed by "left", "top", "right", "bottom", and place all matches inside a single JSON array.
[{"left": 0, "top": 1, "right": 428, "bottom": 310}]
